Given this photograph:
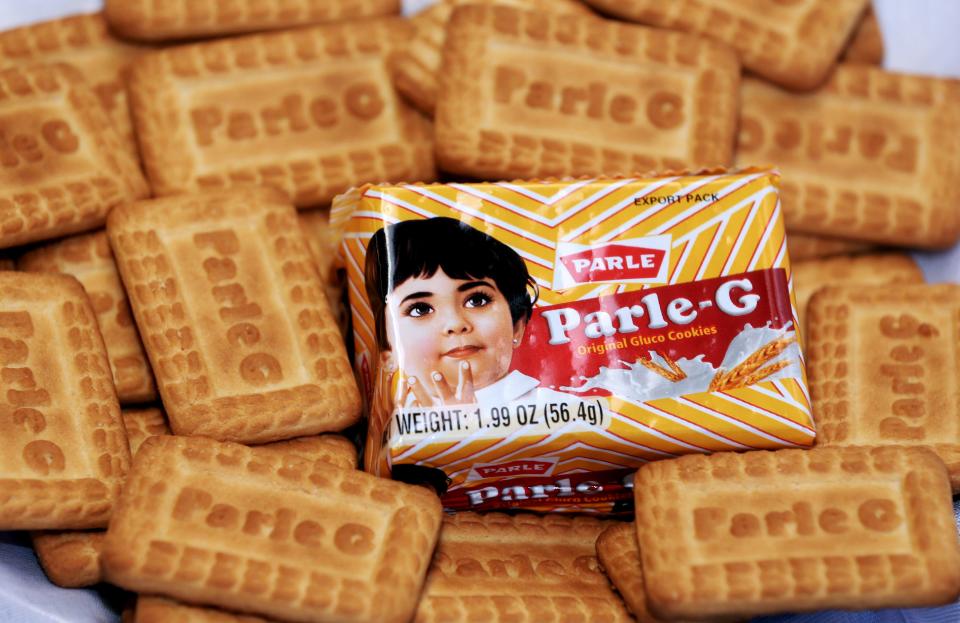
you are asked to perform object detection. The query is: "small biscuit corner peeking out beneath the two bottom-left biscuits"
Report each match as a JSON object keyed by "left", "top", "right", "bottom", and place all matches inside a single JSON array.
[{"left": 30, "top": 530, "right": 106, "bottom": 588}]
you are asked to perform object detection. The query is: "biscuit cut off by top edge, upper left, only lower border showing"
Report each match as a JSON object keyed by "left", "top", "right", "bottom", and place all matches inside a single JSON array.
[{"left": 104, "top": 0, "right": 400, "bottom": 41}]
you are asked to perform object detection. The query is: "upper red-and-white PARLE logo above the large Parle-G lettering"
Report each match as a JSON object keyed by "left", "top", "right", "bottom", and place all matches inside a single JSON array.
[{"left": 553, "top": 236, "right": 671, "bottom": 290}]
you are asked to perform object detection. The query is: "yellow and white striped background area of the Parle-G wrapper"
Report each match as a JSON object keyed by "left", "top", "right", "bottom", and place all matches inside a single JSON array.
[{"left": 331, "top": 169, "right": 815, "bottom": 512}]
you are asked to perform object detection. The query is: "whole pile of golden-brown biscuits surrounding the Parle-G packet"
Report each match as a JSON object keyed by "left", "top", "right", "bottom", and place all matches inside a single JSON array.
[{"left": 0, "top": 0, "right": 960, "bottom": 623}]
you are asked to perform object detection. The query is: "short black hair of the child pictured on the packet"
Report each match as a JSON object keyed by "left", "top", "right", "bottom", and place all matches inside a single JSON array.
[{"left": 364, "top": 216, "right": 538, "bottom": 350}]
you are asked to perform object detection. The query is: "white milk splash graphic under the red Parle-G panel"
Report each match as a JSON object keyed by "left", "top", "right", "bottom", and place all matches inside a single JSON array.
[{"left": 560, "top": 322, "right": 800, "bottom": 402}]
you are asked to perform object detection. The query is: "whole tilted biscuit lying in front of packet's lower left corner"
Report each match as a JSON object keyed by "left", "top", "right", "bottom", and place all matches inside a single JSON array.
[{"left": 103, "top": 437, "right": 442, "bottom": 622}]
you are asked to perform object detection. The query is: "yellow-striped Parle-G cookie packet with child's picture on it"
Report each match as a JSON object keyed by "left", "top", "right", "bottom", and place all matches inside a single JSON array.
[{"left": 331, "top": 168, "right": 815, "bottom": 513}]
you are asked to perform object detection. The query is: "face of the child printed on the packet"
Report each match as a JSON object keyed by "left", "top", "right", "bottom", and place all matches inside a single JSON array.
[{"left": 387, "top": 269, "right": 523, "bottom": 389}]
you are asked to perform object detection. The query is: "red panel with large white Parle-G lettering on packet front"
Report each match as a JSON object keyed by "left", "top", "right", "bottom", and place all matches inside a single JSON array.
[{"left": 512, "top": 268, "right": 793, "bottom": 399}]
